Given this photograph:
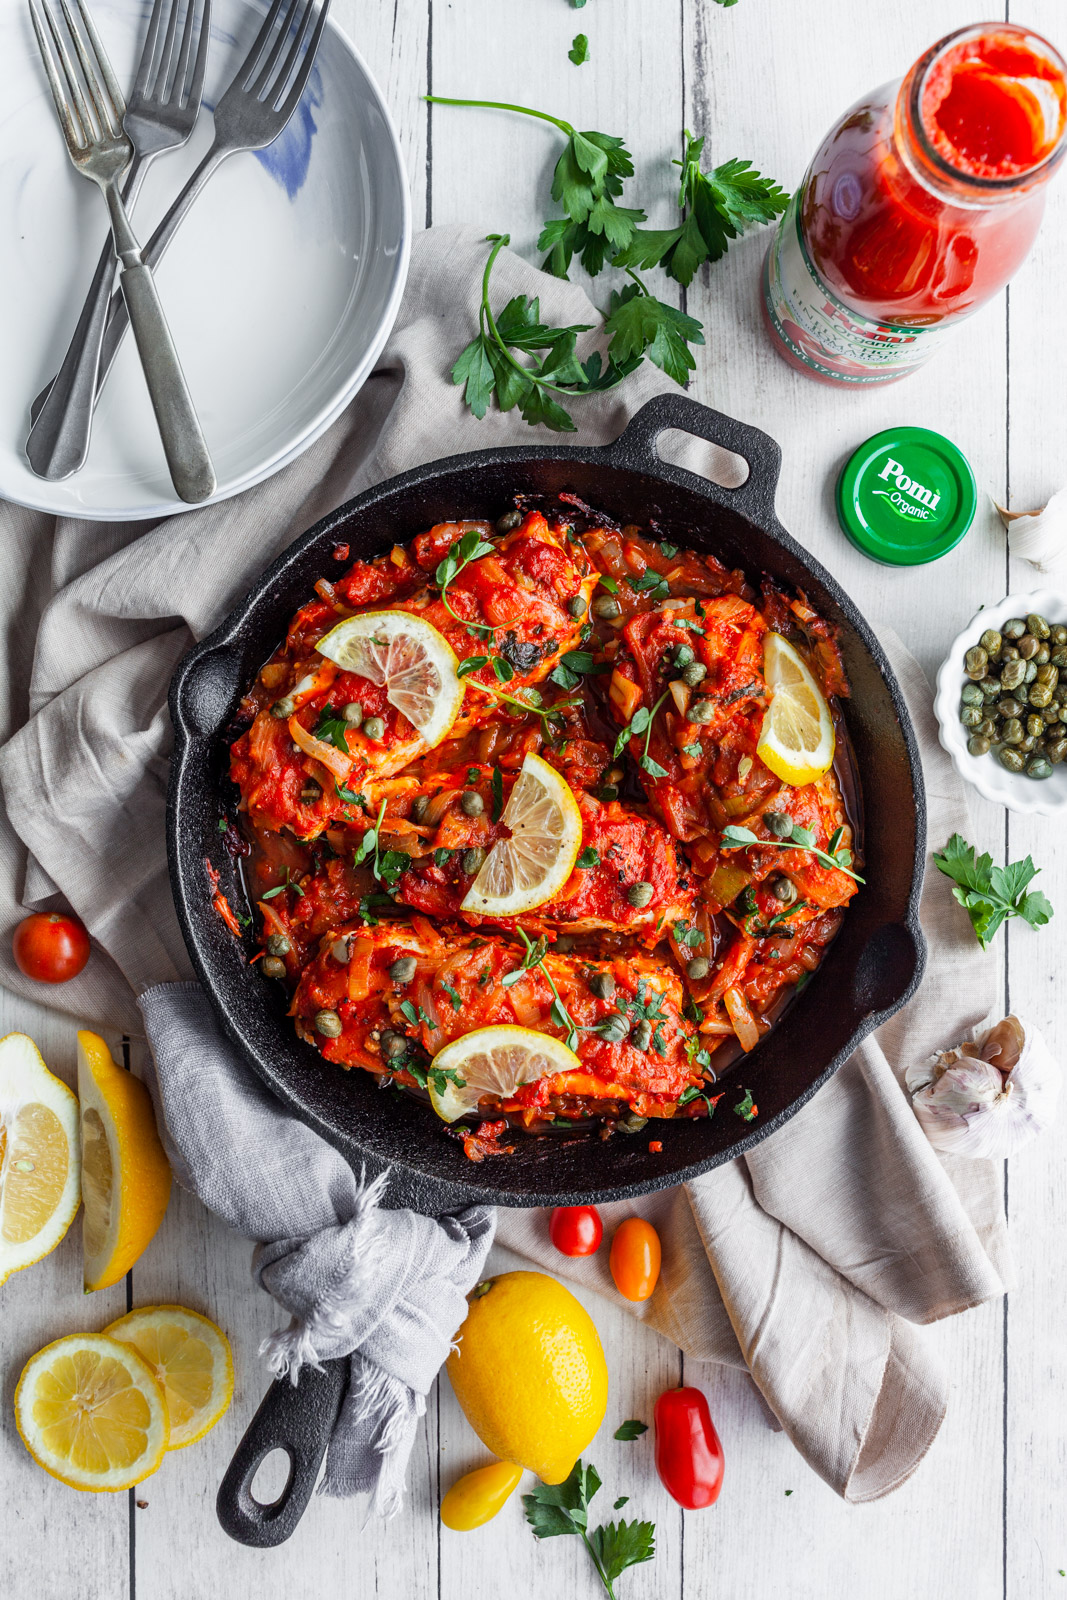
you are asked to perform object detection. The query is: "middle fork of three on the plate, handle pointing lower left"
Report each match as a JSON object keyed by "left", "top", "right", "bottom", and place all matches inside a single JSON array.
[{"left": 26, "top": 0, "right": 211, "bottom": 480}]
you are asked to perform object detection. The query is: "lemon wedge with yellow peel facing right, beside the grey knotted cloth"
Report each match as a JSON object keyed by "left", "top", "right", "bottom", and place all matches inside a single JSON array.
[{"left": 78, "top": 1030, "right": 171, "bottom": 1290}]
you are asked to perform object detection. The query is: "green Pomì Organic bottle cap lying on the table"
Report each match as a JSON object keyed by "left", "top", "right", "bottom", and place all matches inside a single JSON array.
[{"left": 837, "top": 427, "right": 977, "bottom": 566}]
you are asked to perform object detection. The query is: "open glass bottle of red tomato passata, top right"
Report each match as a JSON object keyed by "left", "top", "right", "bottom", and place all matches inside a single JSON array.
[{"left": 763, "top": 22, "right": 1067, "bottom": 384}]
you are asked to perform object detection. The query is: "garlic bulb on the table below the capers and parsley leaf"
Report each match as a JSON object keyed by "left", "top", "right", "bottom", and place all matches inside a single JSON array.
[{"left": 905, "top": 1016, "right": 1062, "bottom": 1158}]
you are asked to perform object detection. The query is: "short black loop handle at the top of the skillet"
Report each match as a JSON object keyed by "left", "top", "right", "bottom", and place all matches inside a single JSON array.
[{"left": 605, "top": 394, "right": 782, "bottom": 522}]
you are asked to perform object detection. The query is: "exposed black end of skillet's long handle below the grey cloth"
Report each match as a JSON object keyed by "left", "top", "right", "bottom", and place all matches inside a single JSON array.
[{"left": 214, "top": 1360, "right": 349, "bottom": 1549}]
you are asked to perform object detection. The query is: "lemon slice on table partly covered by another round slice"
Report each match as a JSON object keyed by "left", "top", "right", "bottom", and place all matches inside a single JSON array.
[{"left": 104, "top": 1306, "right": 234, "bottom": 1450}]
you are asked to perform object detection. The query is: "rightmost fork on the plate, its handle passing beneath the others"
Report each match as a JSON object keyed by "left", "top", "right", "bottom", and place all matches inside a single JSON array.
[{"left": 85, "top": 0, "right": 330, "bottom": 406}]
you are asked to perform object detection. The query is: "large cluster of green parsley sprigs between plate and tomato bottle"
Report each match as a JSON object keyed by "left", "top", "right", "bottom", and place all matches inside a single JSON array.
[{"left": 427, "top": 94, "right": 789, "bottom": 432}]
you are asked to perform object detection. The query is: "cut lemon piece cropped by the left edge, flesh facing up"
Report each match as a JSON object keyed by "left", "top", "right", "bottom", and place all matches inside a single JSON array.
[{"left": 0, "top": 1034, "right": 82, "bottom": 1283}]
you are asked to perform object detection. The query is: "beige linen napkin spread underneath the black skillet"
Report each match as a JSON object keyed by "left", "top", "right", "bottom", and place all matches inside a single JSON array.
[{"left": 0, "top": 229, "right": 1008, "bottom": 1501}]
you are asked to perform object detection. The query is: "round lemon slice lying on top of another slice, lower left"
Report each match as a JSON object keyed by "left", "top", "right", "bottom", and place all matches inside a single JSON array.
[{"left": 14, "top": 1333, "right": 170, "bottom": 1494}]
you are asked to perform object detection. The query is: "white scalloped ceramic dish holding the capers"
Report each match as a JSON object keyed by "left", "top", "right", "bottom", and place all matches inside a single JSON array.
[{"left": 934, "top": 589, "right": 1067, "bottom": 816}]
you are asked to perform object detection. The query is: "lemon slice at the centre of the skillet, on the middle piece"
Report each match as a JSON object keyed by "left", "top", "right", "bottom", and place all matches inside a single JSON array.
[{"left": 462, "top": 755, "right": 582, "bottom": 917}]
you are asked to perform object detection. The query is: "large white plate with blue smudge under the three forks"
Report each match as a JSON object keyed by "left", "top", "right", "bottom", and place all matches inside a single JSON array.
[{"left": 0, "top": 0, "right": 411, "bottom": 520}]
